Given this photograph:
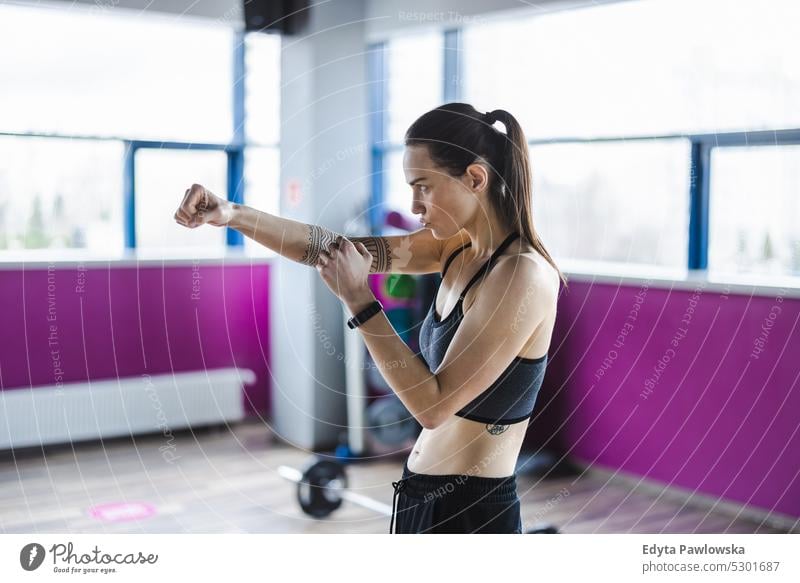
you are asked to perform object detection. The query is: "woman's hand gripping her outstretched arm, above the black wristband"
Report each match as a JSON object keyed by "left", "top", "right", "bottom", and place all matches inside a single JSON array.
[{"left": 315, "top": 236, "right": 374, "bottom": 311}]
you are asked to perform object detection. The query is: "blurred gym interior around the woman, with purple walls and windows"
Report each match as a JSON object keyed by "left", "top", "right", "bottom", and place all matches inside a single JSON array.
[{"left": 0, "top": 0, "right": 800, "bottom": 534}]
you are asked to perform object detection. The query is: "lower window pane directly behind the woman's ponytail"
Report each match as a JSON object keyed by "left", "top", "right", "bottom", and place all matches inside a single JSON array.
[{"left": 530, "top": 139, "right": 690, "bottom": 270}]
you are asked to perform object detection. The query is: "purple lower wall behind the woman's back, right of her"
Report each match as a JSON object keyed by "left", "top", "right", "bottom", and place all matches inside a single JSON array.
[{"left": 528, "top": 281, "right": 800, "bottom": 517}]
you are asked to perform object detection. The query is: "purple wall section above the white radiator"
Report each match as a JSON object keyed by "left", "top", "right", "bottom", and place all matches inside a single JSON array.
[{"left": 0, "top": 263, "right": 270, "bottom": 414}]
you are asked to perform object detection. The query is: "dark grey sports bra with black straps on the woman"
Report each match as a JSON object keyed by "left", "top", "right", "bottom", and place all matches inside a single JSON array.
[{"left": 412, "top": 233, "right": 547, "bottom": 425}]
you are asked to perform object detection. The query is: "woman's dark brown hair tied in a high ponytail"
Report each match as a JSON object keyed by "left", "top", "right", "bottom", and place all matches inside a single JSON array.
[{"left": 405, "top": 103, "right": 567, "bottom": 286}]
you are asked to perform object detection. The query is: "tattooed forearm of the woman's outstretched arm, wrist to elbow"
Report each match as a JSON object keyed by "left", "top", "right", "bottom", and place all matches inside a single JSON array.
[{"left": 228, "top": 204, "right": 392, "bottom": 273}]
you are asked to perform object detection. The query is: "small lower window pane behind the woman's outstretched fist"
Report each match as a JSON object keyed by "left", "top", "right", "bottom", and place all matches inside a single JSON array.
[{"left": 136, "top": 149, "right": 227, "bottom": 255}]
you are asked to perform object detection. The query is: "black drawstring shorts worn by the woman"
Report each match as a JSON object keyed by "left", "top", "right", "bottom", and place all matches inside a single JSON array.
[{"left": 389, "top": 463, "right": 522, "bottom": 534}]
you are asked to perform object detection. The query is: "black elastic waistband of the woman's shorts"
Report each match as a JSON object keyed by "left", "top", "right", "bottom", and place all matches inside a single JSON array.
[{"left": 401, "top": 462, "right": 517, "bottom": 503}]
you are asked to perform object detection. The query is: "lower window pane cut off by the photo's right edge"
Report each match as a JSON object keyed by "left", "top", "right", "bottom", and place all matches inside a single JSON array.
[{"left": 708, "top": 146, "right": 800, "bottom": 276}]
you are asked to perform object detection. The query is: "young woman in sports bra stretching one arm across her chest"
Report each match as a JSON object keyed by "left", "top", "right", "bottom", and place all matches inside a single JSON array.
[{"left": 175, "top": 103, "right": 566, "bottom": 533}]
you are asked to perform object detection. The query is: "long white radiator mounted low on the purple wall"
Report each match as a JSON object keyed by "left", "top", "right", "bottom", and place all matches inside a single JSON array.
[{"left": 0, "top": 368, "right": 256, "bottom": 449}]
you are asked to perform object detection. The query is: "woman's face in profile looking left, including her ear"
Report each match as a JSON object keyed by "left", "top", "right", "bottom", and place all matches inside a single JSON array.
[{"left": 403, "top": 145, "right": 482, "bottom": 239}]
